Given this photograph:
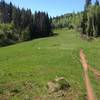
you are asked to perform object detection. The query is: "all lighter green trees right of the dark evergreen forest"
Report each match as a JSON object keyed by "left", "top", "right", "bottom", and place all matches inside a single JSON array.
[{"left": 52, "top": 0, "right": 100, "bottom": 37}]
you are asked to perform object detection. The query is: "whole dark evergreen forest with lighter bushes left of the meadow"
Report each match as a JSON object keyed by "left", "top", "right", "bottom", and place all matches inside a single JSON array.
[{"left": 0, "top": 0, "right": 53, "bottom": 46}]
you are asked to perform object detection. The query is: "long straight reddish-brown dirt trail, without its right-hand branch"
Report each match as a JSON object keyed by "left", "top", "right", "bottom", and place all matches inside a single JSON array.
[{"left": 80, "top": 49, "right": 96, "bottom": 100}]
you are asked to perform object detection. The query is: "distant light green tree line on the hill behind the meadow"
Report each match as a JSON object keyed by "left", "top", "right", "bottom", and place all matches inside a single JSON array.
[{"left": 52, "top": 12, "right": 83, "bottom": 30}]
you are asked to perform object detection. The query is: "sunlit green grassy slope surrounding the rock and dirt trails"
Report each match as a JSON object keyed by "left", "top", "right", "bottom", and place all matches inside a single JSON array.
[{"left": 0, "top": 29, "right": 100, "bottom": 100}]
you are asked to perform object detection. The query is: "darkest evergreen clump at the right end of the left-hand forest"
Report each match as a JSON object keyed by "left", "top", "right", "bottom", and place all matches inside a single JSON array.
[{"left": 34, "top": 12, "right": 51, "bottom": 37}]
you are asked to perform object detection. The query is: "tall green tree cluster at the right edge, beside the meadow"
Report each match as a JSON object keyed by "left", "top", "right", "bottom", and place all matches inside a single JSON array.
[{"left": 81, "top": 0, "right": 100, "bottom": 37}]
